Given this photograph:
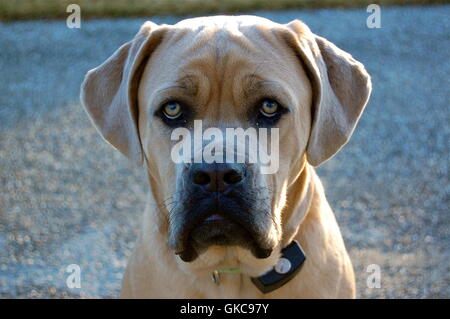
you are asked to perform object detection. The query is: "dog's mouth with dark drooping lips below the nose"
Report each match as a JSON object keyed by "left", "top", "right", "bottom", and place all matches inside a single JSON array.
[{"left": 176, "top": 211, "right": 273, "bottom": 262}]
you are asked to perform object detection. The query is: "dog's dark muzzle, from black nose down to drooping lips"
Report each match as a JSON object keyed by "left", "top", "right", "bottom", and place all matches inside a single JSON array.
[{"left": 169, "top": 163, "right": 275, "bottom": 262}]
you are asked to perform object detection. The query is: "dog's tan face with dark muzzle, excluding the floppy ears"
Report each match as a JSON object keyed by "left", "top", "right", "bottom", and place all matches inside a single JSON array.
[{"left": 138, "top": 18, "right": 311, "bottom": 261}]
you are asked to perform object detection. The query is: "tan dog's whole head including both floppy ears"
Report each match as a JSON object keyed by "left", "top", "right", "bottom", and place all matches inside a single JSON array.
[{"left": 81, "top": 16, "right": 371, "bottom": 271}]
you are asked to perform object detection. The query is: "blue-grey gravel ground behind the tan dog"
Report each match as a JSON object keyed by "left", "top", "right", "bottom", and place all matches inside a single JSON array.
[{"left": 0, "top": 6, "right": 450, "bottom": 298}]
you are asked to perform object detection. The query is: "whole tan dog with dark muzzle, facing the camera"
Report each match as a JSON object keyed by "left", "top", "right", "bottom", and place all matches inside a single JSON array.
[{"left": 81, "top": 16, "right": 371, "bottom": 298}]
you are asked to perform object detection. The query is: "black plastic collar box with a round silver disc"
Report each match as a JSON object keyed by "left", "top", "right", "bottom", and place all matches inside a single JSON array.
[{"left": 252, "top": 240, "right": 306, "bottom": 294}]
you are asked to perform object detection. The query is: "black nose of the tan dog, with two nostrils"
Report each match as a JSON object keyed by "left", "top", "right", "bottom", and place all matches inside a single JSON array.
[{"left": 192, "top": 163, "right": 245, "bottom": 192}]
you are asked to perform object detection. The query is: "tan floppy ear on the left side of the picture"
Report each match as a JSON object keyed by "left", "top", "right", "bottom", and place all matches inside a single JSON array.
[{"left": 80, "top": 21, "right": 162, "bottom": 165}]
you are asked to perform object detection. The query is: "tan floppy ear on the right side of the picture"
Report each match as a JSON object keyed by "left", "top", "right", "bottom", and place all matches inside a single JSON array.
[{"left": 286, "top": 20, "right": 372, "bottom": 166}]
